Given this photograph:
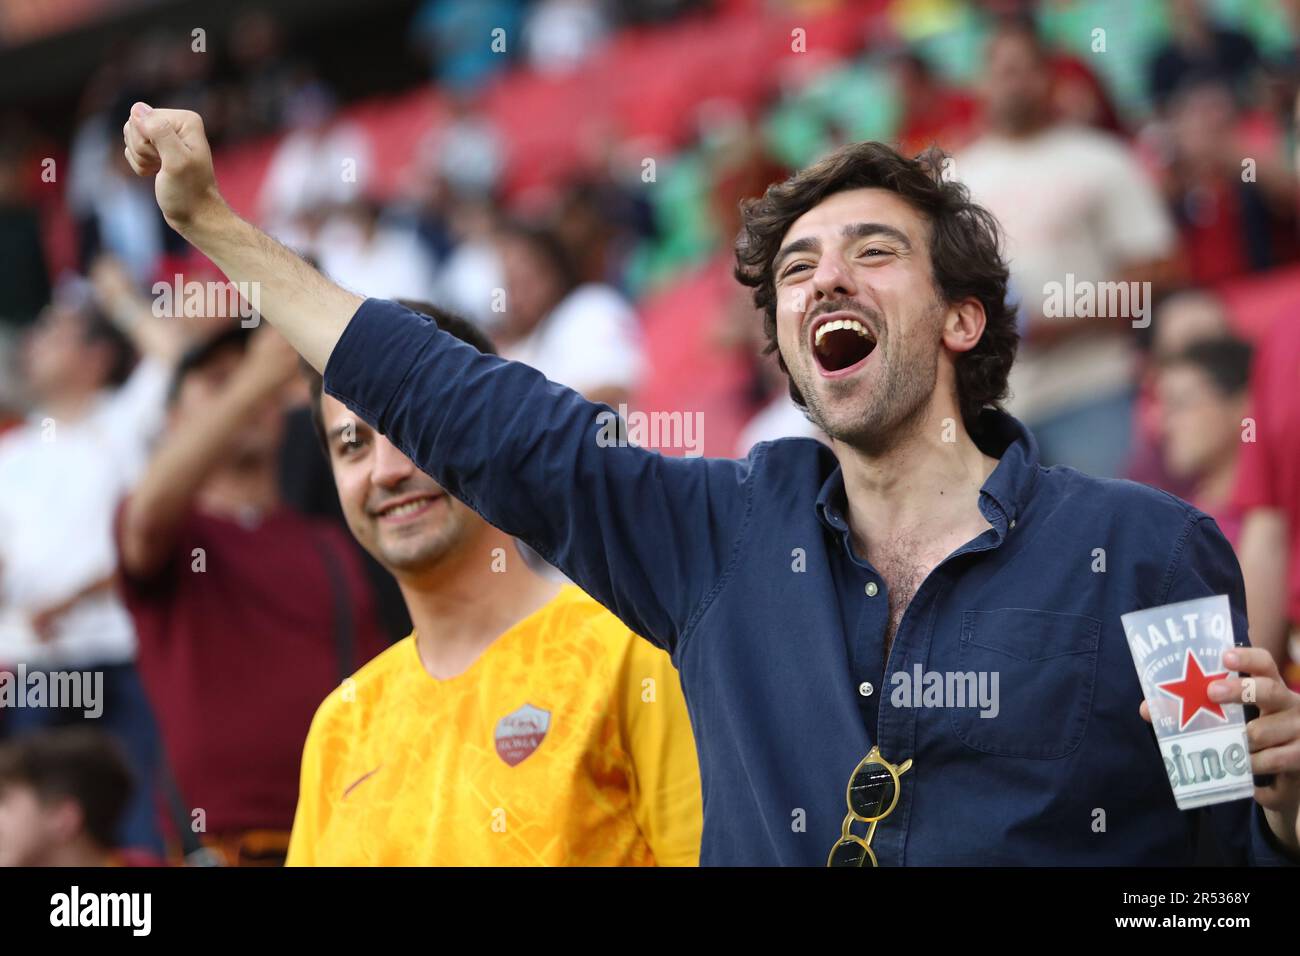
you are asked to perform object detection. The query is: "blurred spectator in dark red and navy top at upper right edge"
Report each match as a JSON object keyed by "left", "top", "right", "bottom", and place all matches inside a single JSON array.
[{"left": 1164, "top": 82, "right": 1296, "bottom": 282}]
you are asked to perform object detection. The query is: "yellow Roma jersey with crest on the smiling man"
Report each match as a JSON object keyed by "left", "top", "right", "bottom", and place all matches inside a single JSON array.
[{"left": 287, "top": 585, "right": 702, "bottom": 866}]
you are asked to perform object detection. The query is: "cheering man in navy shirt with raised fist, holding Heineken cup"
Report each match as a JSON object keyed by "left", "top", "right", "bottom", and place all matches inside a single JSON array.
[{"left": 125, "top": 104, "right": 1300, "bottom": 865}]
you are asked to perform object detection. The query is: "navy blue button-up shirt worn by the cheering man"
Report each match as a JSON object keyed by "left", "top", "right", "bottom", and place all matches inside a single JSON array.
[{"left": 325, "top": 299, "right": 1283, "bottom": 866}]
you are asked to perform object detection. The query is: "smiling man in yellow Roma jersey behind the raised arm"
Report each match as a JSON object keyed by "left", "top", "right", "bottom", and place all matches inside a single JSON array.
[{"left": 289, "top": 302, "right": 701, "bottom": 866}]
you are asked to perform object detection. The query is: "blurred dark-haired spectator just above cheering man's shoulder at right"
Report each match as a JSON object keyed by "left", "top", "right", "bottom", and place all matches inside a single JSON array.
[{"left": 1156, "top": 338, "right": 1252, "bottom": 545}]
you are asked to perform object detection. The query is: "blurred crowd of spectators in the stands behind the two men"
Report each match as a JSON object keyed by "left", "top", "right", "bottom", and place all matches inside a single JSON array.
[{"left": 0, "top": 0, "right": 1300, "bottom": 865}]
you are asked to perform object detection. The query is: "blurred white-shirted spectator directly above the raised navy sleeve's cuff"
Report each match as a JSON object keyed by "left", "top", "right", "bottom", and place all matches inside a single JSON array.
[{"left": 313, "top": 198, "right": 434, "bottom": 299}]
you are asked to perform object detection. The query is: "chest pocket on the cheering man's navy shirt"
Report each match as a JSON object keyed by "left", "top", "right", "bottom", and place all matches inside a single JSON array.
[{"left": 949, "top": 607, "right": 1101, "bottom": 760}]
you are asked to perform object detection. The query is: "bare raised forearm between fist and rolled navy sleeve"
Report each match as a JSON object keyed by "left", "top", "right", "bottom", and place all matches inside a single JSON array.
[{"left": 182, "top": 203, "right": 363, "bottom": 372}]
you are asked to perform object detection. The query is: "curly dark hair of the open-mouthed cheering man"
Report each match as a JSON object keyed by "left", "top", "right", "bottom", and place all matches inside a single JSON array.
[{"left": 736, "top": 142, "right": 1019, "bottom": 432}]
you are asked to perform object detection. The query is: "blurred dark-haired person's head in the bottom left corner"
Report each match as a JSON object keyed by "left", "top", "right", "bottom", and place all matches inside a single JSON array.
[{"left": 0, "top": 728, "right": 133, "bottom": 866}]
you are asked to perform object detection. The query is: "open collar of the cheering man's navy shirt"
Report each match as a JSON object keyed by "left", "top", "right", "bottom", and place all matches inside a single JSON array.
[{"left": 816, "top": 408, "right": 1039, "bottom": 537}]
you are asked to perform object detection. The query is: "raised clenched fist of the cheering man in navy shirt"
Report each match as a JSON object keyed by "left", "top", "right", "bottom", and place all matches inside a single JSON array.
[{"left": 122, "top": 103, "right": 225, "bottom": 235}]
